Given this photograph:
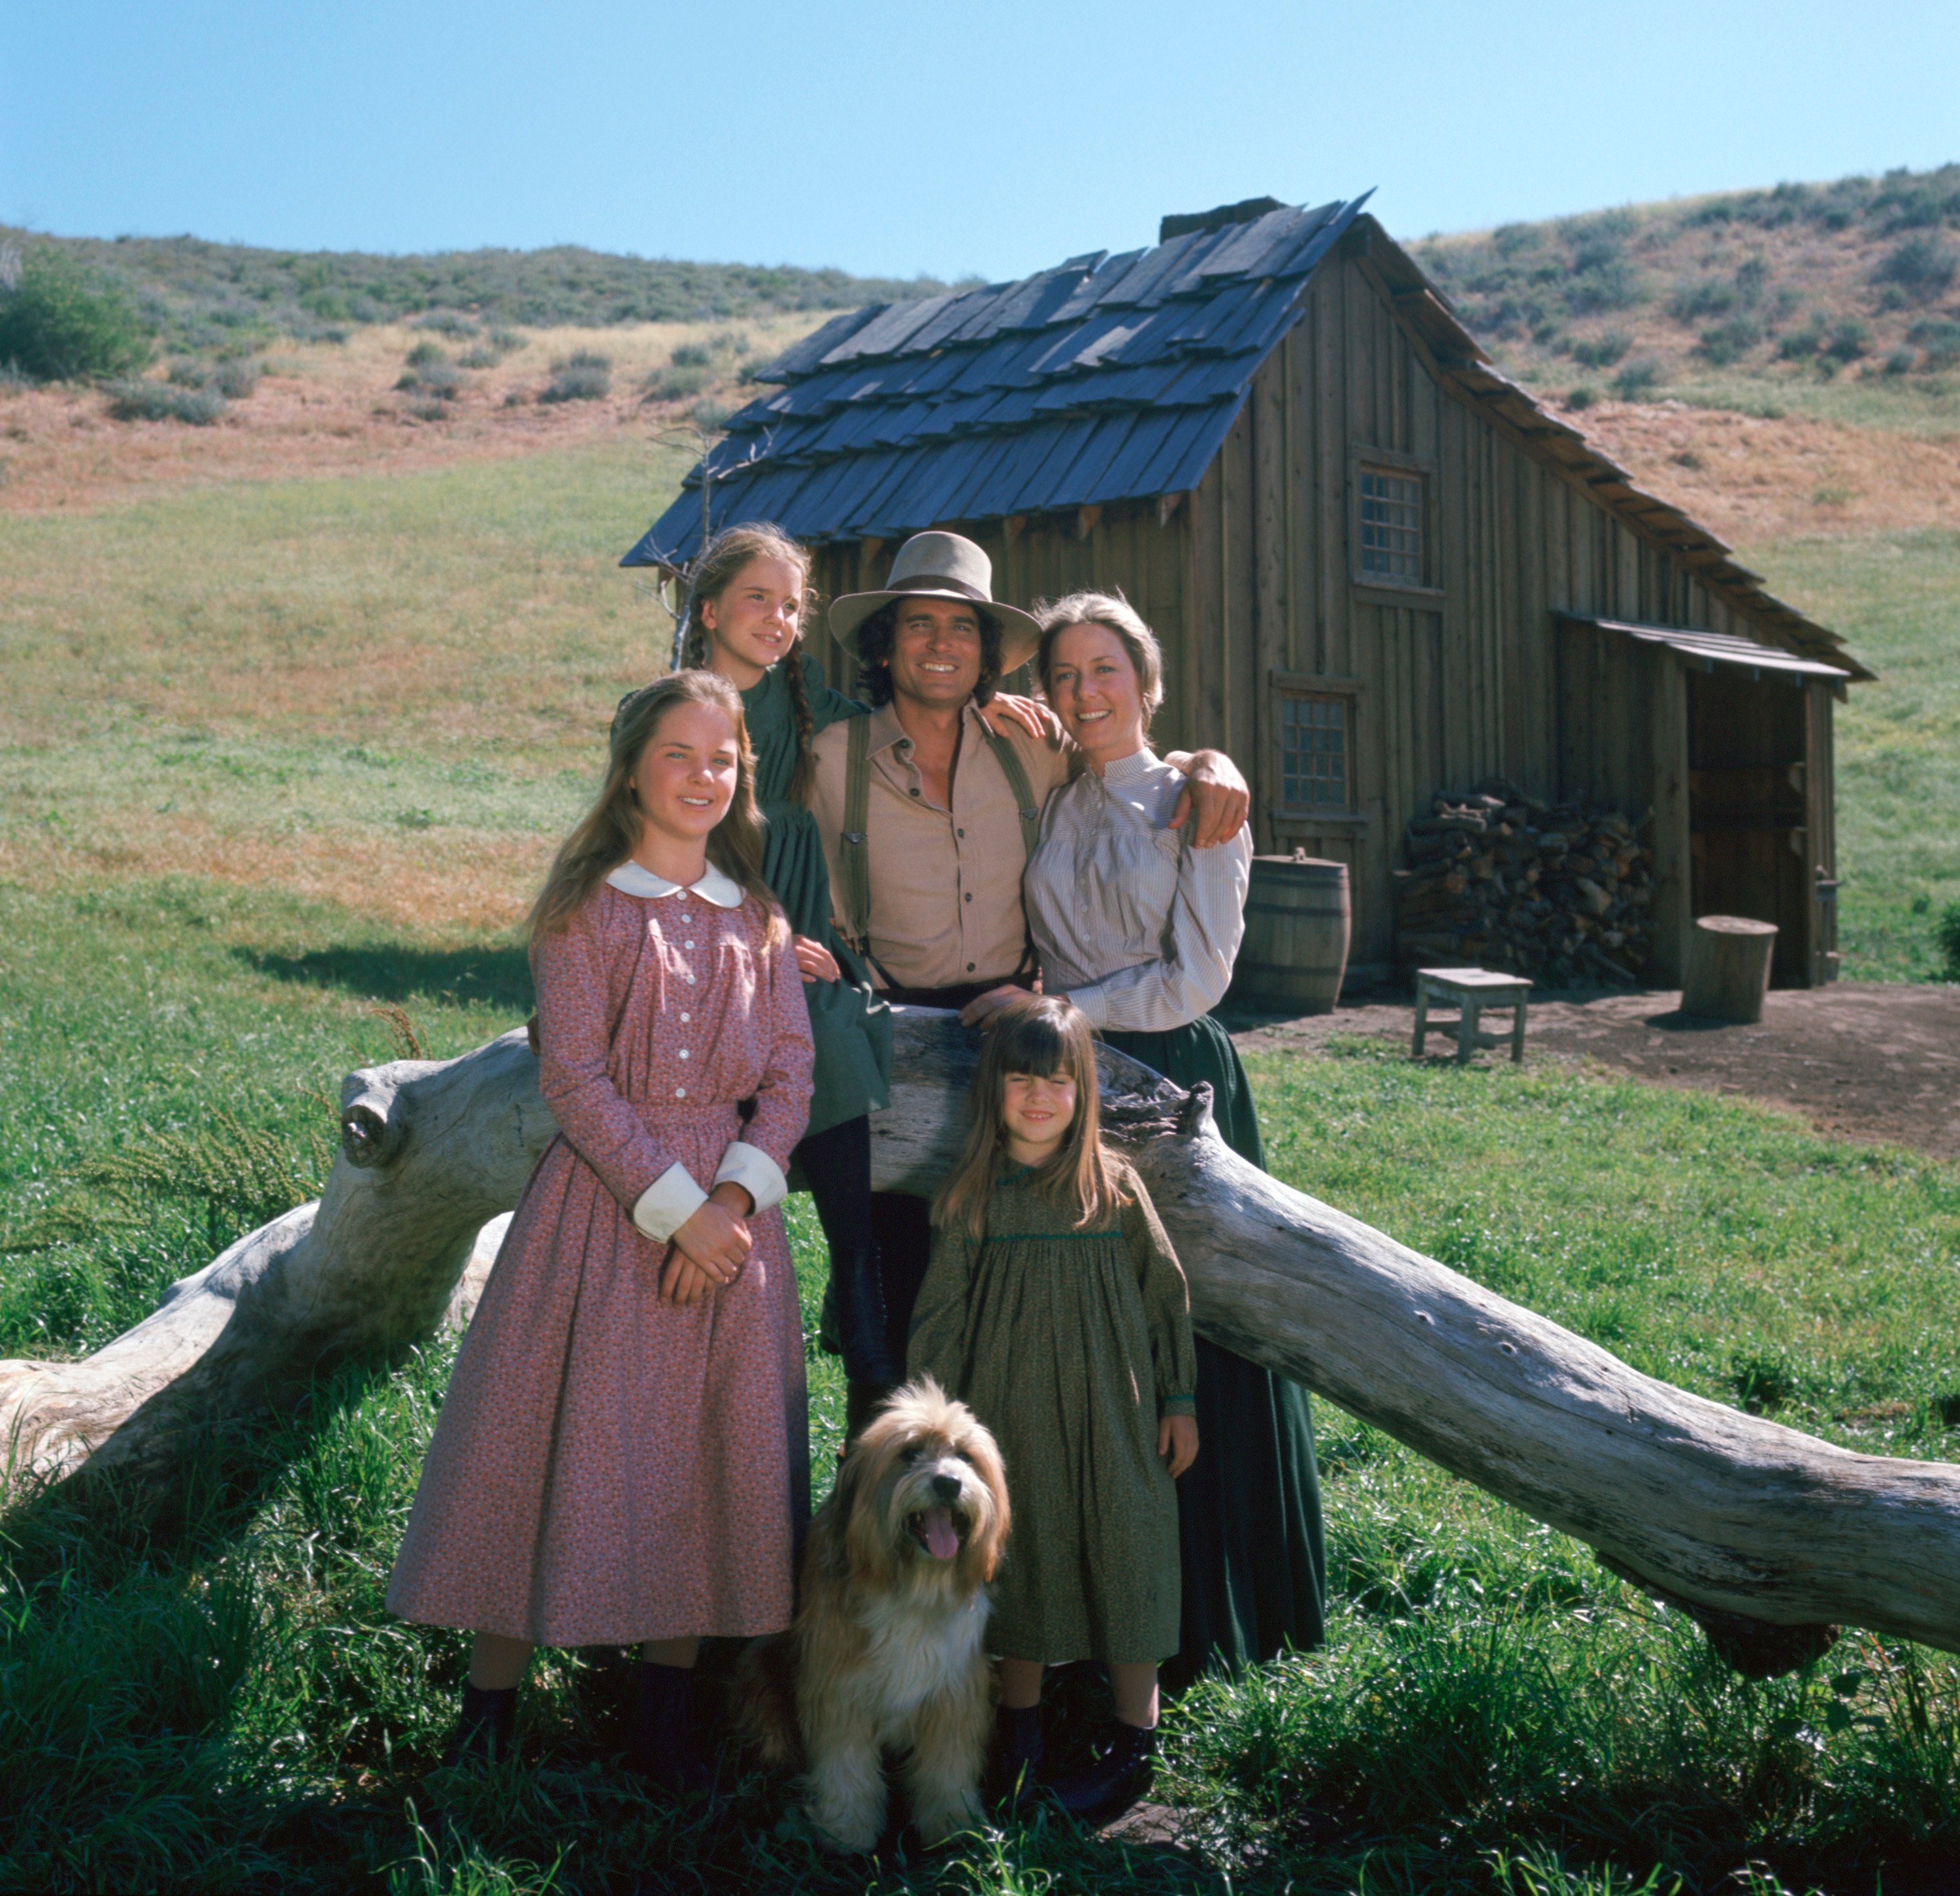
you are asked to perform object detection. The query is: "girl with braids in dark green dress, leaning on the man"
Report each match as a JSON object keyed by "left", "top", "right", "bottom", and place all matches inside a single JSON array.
[{"left": 680, "top": 521, "right": 900, "bottom": 1390}]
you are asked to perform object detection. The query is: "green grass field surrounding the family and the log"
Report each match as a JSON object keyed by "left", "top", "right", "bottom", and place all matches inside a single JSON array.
[{"left": 0, "top": 443, "right": 1960, "bottom": 1896}]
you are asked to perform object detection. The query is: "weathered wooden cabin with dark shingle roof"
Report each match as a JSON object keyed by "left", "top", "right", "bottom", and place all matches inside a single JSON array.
[{"left": 623, "top": 200, "right": 1870, "bottom": 987}]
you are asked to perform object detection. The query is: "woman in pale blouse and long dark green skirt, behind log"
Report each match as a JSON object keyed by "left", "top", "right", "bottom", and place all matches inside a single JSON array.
[{"left": 962, "top": 592, "right": 1325, "bottom": 1688}]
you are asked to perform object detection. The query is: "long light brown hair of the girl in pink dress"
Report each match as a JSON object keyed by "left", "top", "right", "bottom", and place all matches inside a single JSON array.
[{"left": 525, "top": 670, "right": 790, "bottom": 947}]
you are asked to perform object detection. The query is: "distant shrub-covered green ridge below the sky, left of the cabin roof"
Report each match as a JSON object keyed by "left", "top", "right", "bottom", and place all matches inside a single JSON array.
[{"left": 0, "top": 225, "right": 945, "bottom": 353}]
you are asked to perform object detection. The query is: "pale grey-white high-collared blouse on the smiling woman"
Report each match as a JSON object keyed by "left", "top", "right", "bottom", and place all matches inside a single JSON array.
[{"left": 1023, "top": 749, "right": 1252, "bottom": 1034}]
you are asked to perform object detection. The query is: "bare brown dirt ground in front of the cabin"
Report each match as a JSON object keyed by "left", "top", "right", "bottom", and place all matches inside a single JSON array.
[{"left": 1235, "top": 983, "right": 1960, "bottom": 1159}]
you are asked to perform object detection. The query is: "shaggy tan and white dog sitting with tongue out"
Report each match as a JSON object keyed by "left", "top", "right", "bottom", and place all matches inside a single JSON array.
[{"left": 737, "top": 1379, "right": 1007, "bottom": 1851}]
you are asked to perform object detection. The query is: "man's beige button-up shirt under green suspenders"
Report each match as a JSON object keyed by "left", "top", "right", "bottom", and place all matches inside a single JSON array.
[{"left": 809, "top": 704, "right": 1068, "bottom": 989}]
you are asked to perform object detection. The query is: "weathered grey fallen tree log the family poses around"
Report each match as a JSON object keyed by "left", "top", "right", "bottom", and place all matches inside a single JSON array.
[{"left": 0, "top": 1008, "right": 1960, "bottom": 1671}]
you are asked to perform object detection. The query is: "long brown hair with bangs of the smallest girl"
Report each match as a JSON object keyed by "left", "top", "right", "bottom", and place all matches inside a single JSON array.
[{"left": 933, "top": 994, "right": 1129, "bottom": 1237}]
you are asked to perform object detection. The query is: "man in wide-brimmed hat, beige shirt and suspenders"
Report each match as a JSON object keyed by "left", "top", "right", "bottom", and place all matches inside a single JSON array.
[{"left": 809, "top": 533, "right": 1249, "bottom": 1426}]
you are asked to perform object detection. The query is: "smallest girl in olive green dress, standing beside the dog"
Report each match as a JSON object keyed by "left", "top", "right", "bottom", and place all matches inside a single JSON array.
[{"left": 906, "top": 994, "right": 1198, "bottom": 1820}]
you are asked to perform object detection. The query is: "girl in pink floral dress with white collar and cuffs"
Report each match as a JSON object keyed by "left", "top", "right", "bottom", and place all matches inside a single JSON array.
[{"left": 388, "top": 670, "right": 811, "bottom": 1790}]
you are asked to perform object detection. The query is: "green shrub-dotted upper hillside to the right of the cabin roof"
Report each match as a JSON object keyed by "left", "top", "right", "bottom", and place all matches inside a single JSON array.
[{"left": 1413, "top": 165, "right": 1960, "bottom": 427}]
